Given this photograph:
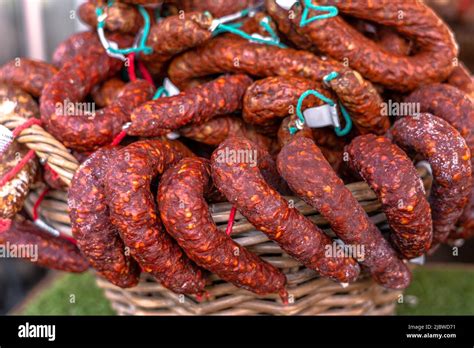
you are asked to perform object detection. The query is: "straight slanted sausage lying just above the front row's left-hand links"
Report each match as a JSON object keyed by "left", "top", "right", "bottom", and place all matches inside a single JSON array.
[{"left": 128, "top": 75, "right": 252, "bottom": 137}]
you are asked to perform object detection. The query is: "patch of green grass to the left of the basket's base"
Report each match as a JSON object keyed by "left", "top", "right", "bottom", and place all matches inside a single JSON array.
[{"left": 21, "top": 273, "right": 114, "bottom": 315}]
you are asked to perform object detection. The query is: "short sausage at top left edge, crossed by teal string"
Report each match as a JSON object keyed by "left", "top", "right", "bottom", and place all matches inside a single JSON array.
[{"left": 78, "top": 0, "right": 143, "bottom": 34}]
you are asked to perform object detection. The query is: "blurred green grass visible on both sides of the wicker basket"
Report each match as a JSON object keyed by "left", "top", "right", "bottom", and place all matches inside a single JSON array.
[{"left": 17, "top": 266, "right": 474, "bottom": 315}]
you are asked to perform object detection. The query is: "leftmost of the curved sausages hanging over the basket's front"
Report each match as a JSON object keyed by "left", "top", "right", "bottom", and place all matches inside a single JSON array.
[{"left": 68, "top": 147, "right": 140, "bottom": 288}]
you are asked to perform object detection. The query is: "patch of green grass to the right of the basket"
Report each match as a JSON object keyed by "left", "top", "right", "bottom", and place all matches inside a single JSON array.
[{"left": 397, "top": 267, "right": 474, "bottom": 315}]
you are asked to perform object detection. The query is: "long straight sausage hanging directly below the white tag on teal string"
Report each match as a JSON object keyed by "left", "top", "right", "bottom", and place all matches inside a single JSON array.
[{"left": 277, "top": 137, "right": 411, "bottom": 289}]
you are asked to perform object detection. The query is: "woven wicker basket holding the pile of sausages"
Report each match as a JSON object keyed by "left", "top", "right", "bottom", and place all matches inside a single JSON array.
[{"left": 26, "top": 163, "right": 431, "bottom": 315}]
